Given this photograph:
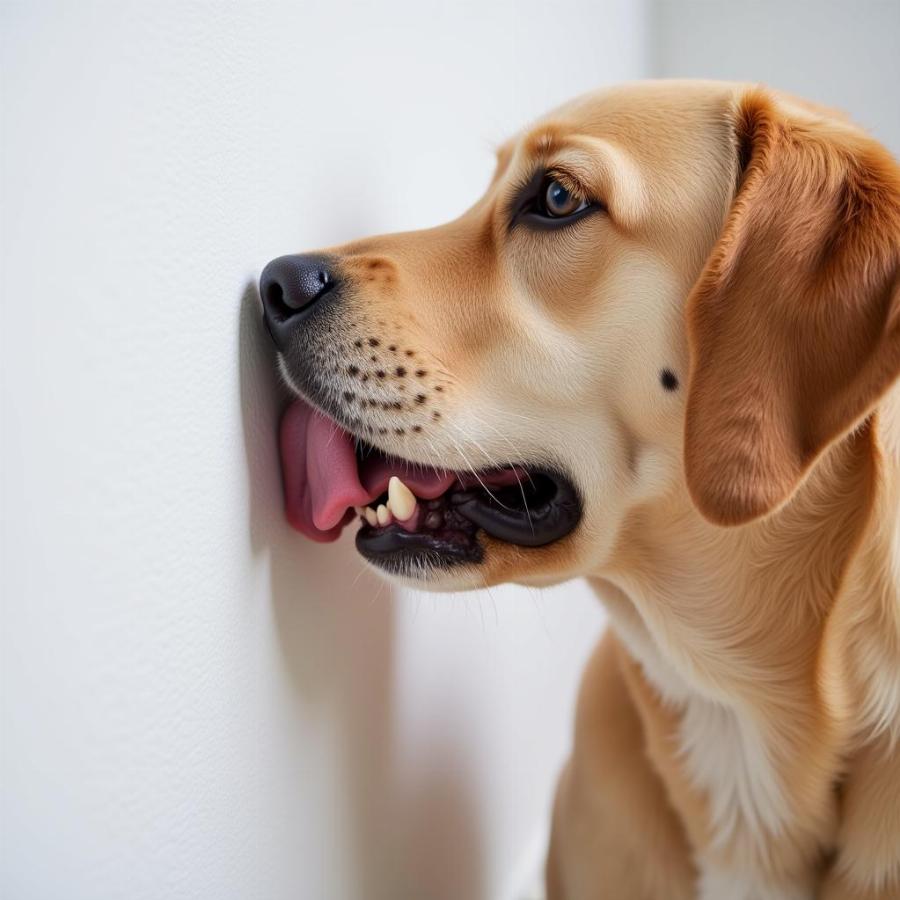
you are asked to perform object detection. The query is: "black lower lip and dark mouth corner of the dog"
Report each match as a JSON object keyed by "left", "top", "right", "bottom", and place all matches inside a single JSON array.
[{"left": 356, "top": 470, "right": 582, "bottom": 575}]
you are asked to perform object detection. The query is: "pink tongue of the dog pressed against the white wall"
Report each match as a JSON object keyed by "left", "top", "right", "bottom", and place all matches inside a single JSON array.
[{"left": 280, "top": 400, "right": 456, "bottom": 541}]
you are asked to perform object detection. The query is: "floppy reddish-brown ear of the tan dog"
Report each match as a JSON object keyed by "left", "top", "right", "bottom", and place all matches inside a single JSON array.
[{"left": 684, "top": 90, "right": 900, "bottom": 525}]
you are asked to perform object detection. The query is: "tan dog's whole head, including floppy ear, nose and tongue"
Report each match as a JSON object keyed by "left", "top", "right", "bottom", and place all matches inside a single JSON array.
[{"left": 260, "top": 82, "right": 900, "bottom": 588}]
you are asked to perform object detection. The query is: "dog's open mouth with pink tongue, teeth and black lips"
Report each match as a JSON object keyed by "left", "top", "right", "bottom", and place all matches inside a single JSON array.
[{"left": 281, "top": 400, "right": 582, "bottom": 575}]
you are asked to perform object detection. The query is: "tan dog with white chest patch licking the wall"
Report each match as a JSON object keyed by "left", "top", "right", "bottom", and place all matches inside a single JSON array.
[{"left": 260, "top": 81, "right": 900, "bottom": 900}]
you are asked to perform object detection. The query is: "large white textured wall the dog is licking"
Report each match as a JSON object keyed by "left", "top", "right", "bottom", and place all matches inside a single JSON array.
[{"left": 0, "top": 7, "right": 645, "bottom": 900}]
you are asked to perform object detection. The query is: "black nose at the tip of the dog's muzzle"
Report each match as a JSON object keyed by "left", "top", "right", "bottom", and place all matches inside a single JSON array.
[{"left": 259, "top": 255, "right": 336, "bottom": 349}]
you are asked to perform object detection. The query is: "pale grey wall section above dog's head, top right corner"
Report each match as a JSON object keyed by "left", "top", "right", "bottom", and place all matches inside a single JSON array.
[{"left": 648, "top": 0, "right": 900, "bottom": 156}]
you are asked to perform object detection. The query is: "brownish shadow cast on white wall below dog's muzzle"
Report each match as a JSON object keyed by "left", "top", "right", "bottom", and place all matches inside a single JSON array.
[{"left": 239, "top": 282, "right": 487, "bottom": 900}]
